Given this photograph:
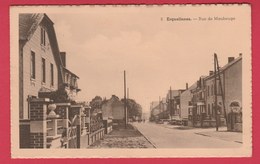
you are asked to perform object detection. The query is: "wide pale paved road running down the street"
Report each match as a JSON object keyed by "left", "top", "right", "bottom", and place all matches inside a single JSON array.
[{"left": 133, "top": 122, "right": 242, "bottom": 148}]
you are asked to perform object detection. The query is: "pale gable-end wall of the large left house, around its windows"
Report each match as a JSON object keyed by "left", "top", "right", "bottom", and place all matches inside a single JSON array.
[{"left": 20, "top": 23, "right": 58, "bottom": 119}]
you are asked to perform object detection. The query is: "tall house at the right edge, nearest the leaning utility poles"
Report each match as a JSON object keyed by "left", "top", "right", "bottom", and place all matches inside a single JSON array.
[{"left": 205, "top": 54, "right": 242, "bottom": 131}]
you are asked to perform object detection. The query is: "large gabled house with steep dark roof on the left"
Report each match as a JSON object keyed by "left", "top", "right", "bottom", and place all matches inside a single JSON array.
[{"left": 19, "top": 14, "right": 79, "bottom": 119}]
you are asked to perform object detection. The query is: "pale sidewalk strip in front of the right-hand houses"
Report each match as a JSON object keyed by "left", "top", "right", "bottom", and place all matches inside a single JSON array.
[{"left": 154, "top": 121, "right": 243, "bottom": 144}]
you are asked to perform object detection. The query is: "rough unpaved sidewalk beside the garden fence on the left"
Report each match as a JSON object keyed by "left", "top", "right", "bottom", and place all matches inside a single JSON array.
[{"left": 89, "top": 125, "right": 153, "bottom": 149}]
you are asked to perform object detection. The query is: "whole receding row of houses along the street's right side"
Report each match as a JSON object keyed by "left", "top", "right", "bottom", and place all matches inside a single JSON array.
[{"left": 150, "top": 54, "right": 242, "bottom": 131}]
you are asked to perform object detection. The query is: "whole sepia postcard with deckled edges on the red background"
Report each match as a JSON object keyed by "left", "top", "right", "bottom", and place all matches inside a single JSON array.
[{"left": 10, "top": 4, "right": 252, "bottom": 158}]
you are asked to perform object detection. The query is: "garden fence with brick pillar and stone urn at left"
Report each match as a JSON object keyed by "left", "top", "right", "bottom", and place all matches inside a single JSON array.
[{"left": 20, "top": 98, "right": 105, "bottom": 149}]
